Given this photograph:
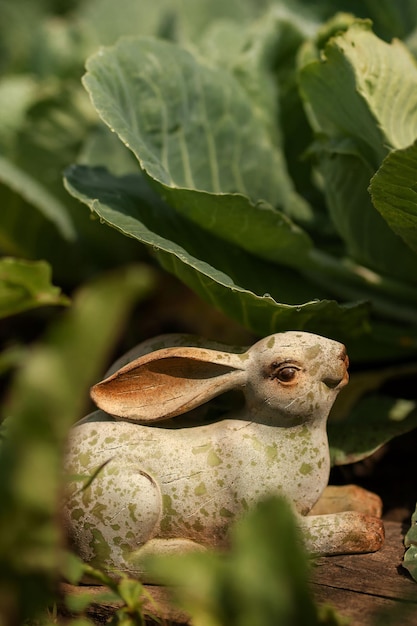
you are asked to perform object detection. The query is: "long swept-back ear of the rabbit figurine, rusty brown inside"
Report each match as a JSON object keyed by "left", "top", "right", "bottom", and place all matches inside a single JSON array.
[{"left": 91, "top": 347, "right": 247, "bottom": 422}]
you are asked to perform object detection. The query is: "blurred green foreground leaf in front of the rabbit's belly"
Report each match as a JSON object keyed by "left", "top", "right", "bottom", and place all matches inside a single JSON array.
[{"left": 147, "top": 498, "right": 338, "bottom": 626}]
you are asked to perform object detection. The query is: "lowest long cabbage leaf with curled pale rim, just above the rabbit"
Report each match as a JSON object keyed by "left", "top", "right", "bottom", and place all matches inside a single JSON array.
[{"left": 66, "top": 167, "right": 367, "bottom": 338}]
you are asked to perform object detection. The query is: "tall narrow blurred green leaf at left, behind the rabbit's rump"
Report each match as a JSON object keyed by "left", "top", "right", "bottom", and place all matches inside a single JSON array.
[{"left": 0, "top": 266, "right": 153, "bottom": 625}]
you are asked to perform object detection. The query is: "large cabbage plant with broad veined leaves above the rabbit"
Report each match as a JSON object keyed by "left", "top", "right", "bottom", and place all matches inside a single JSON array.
[{"left": 66, "top": 14, "right": 417, "bottom": 363}]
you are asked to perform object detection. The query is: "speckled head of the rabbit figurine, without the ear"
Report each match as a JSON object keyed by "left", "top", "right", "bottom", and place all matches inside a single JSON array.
[{"left": 245, "top": 331, "right": 349, "bottom": 426}]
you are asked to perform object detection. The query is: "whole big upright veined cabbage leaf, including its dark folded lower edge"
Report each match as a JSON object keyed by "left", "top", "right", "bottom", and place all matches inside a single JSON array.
[{"left": 84, "top": 38, "right": 309, "bottom": 263}]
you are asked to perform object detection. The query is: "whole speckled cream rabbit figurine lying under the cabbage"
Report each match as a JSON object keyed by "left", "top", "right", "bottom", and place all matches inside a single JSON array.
[{"left": 64, "top": 331, "right": 384, "bottom": 582}]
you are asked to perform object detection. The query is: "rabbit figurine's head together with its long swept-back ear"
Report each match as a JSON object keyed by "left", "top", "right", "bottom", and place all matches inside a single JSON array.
[{"left": 91, "top": 331, "right": 348, "bottom": 426}]
